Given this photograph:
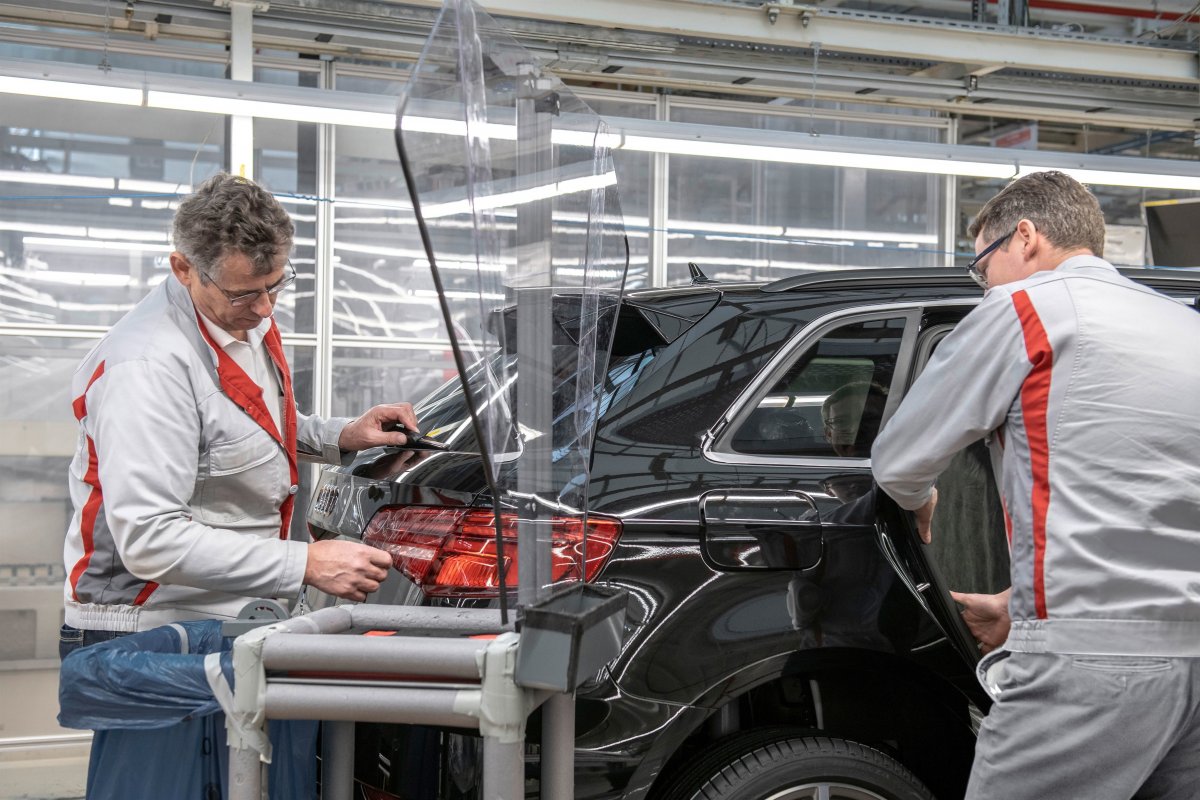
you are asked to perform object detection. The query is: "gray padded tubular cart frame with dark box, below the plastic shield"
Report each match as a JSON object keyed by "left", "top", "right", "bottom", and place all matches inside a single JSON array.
[{"left": 226, "top": 584, "right": 625, "bottom": 800}]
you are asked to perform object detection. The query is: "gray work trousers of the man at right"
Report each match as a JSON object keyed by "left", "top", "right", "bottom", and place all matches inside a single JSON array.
[{"left": 966, "top": 652, "right": 1200, "bottom": 800}]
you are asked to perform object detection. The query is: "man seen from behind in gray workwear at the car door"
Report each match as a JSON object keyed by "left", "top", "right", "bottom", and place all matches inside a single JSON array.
[{"left": 872, "top": 172, "right": 1200, "bottom": 800}]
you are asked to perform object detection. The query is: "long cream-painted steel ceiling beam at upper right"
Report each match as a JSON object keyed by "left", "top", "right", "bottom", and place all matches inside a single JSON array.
[{"left": 392, "top": 0, "right": 1200, "bottom": 84}]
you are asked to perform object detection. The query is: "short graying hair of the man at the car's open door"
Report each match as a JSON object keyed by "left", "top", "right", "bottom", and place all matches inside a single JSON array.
[{"left": 967, "top": 172, "right": 1104, "bottom": 257}]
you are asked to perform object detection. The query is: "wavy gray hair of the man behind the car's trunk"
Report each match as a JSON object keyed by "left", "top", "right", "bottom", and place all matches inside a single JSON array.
[{"left": 172, "top": 173, "right": 295, "bottom": 281}]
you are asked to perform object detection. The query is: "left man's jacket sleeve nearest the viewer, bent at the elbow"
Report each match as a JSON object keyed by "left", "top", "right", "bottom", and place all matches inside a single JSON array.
[{"left": 83, "top": 360, "right": 307, "bottom": 597}]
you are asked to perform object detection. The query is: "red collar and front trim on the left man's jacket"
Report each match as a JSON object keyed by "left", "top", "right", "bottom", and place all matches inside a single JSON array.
[{"left": 196, "top": 312, "right": 300, "bottom": 539}]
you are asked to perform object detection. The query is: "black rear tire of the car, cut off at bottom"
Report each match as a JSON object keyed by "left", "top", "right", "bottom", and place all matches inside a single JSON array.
[{"left": 661, "top": 732, "right": 934, "bottom": 800}]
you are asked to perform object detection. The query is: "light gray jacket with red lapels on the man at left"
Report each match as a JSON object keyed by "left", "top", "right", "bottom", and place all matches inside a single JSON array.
[{"left": 64, "top": 276, "right": 347, "bottom": 631}]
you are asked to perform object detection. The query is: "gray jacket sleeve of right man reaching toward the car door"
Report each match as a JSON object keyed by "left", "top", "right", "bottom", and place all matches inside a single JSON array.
[{"left": 871, "top": 288, "right": 1031, "bottom": 511}]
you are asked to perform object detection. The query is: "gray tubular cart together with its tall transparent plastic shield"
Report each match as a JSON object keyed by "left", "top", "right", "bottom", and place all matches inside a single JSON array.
[{"left": 227, "top": 0, "right": 629, "bottom": 800}]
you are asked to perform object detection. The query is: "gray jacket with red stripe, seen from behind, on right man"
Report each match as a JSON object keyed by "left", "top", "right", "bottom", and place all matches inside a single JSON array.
[{"left": 871, "top": 255, "right": 1200, "bottom": 656}]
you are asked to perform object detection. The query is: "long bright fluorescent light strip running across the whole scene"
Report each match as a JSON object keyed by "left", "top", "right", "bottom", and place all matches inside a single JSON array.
[{"left": 0, "top": 59, "right": 1200, "bottom": 194}]
